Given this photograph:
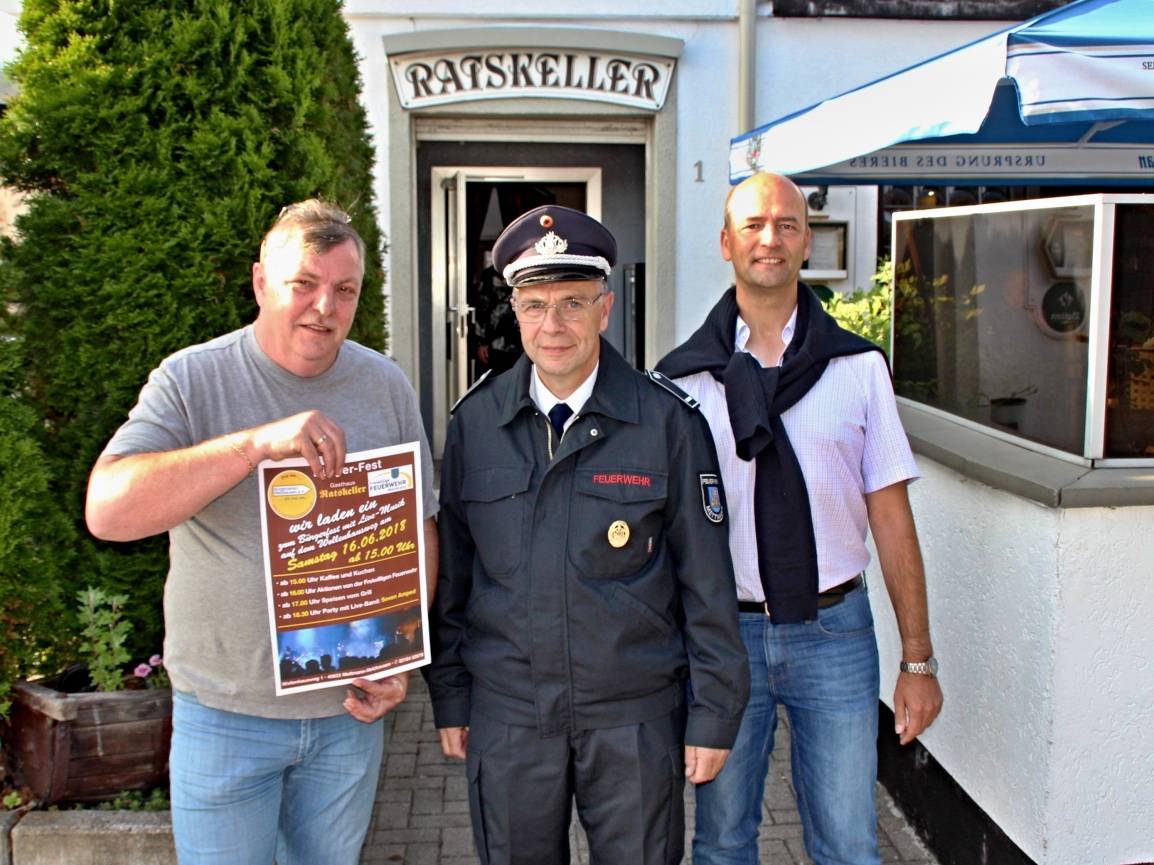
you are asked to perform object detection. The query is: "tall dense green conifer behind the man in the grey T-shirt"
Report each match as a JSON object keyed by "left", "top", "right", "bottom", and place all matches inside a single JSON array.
[{"left": 0, "top": 0, "right": 384, "bottom": 678}]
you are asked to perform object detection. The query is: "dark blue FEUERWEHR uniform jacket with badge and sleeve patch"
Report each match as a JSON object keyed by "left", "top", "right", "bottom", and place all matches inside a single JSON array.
[{"left": 426, "top": 340, "right": 749, "bottom": 747}]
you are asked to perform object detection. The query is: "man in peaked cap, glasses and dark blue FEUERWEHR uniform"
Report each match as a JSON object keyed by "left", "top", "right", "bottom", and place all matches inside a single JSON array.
[{"left": 426, "top": 205, "right": 749, "bottom": 865}]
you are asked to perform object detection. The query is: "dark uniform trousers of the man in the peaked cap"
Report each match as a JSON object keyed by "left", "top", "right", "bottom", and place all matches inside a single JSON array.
[{"left": 466, "top": 707, "right": 685, "bottom": 865}]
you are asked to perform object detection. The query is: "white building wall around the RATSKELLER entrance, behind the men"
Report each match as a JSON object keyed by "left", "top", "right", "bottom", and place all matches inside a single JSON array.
[{"left": 346, "top": 0, "right": 1005, "bottom": 454}]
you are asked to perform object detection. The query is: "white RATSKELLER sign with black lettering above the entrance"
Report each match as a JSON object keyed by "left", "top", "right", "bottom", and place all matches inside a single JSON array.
[{"left": 389, "top": 48, "right": 675, "bottom": 111}]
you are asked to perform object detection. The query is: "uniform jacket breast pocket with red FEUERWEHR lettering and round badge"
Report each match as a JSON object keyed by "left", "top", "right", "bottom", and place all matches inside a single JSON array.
[{"left": 569, "top": 468, "right": 668, "bottom": 577}]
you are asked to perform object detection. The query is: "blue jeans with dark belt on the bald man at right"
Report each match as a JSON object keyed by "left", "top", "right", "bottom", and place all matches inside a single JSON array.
[{"left": 694, "top": 587, "right": 881, "bottom": 865}]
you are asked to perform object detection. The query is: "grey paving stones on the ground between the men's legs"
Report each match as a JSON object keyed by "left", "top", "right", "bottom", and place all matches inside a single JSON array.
[{"left": 361, "top": 675, "right": 938, "bottom": 865}]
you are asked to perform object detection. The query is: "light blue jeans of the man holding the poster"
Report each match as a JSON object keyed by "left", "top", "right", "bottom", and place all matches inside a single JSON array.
[{"left": 168, "top": 692, "right": 384, "bottom": 865}]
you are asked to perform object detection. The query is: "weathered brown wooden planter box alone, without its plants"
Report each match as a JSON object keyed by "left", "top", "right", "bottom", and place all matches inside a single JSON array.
[{"left": 8, "top": 682, "right": 172, "bottom": 805}]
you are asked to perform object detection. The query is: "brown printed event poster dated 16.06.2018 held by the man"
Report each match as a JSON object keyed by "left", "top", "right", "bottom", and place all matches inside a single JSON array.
[{"left": 257, "top": 442, "right": 429, "bottom": 695}]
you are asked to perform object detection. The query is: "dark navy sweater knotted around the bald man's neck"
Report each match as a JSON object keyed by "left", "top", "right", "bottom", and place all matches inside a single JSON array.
[{"left": 657, "top": 289, "right": 882, "bottom": 623}]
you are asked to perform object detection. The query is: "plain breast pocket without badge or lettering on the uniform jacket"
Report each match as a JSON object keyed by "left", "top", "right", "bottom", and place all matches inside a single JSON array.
[{"left": 460, "top": 466, "right": 532, "bottom": 577}]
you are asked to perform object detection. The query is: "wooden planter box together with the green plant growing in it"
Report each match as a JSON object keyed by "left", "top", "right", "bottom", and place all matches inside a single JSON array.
[{"left": 8, "top": 587, "right": 172, "bottom": 805}]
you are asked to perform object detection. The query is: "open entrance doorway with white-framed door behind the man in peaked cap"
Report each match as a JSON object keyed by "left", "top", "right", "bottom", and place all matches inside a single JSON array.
[{"left": 419, "top": 142, "right": 645, "bottom": 458}]
